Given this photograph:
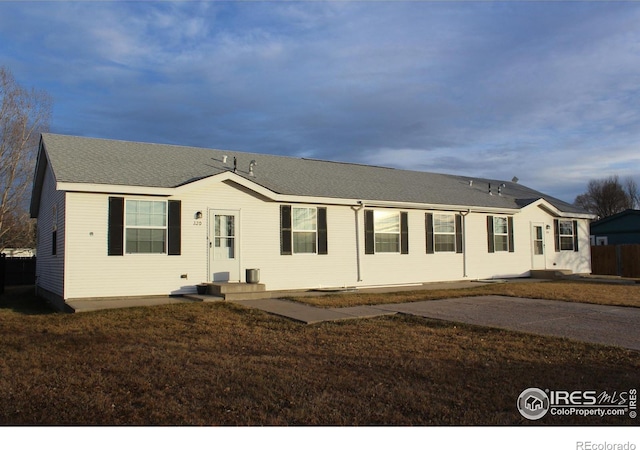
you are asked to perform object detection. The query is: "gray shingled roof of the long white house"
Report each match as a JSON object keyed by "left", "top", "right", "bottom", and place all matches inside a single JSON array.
[{"left": 35, "top": 134, "right": 585, "bottom": 214}]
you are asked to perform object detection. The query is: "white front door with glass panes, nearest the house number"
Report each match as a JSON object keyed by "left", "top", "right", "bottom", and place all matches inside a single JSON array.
[{"left": 209, "top": 210, "right": 240, "bottom": 281}]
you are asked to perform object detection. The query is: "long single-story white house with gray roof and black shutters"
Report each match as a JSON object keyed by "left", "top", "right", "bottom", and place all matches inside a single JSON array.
[{"left": 31, "top": 134, "right": 593, "bottom": 307}]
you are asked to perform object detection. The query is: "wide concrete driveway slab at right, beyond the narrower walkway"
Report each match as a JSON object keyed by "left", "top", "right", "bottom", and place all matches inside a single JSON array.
[{"left": 375, "top": 295, "right": 640, "bottom": 350}]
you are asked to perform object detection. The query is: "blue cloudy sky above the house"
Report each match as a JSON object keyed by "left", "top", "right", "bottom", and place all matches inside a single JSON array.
[{"left": 0, "top": 1, "right": 640, "bottom": 202}]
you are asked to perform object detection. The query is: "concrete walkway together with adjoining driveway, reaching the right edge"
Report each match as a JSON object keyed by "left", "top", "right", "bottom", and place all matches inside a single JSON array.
[{"left": 233, "top": 295, "right": 640, "bottom": 351}]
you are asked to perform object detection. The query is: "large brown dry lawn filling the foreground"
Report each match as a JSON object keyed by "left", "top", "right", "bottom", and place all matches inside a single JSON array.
[{"left": 0, "top": 288, "right": 640, "bottom": 425}]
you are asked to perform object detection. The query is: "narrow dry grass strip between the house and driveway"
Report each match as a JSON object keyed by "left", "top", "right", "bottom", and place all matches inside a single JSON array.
[{"left": 290, "top": 281, "right": 640, "bottom": 308}]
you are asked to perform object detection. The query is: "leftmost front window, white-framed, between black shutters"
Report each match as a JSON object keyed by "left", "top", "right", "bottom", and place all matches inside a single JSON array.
[{"left": 125, "top": 200, "right": 167, "bottom": 253}]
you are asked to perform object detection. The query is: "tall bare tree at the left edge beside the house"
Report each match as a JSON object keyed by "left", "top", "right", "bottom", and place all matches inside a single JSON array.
[{"left": 0, "top": 67, "right": 52, "bottom": 250}]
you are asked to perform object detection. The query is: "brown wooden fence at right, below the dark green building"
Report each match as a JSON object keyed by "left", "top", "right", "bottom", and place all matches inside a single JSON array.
[{"left": 591, "top": 244, "right": 640, "bottom": 278}]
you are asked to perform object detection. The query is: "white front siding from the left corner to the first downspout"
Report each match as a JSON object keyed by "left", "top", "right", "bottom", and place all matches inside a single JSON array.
[{"left": 65, "top": 179, "right": 356, "bottom": 298}]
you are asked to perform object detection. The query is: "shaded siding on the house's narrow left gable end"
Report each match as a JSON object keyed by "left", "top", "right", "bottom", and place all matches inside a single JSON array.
[{"left": 36, "top": 163, "right": 66, "bottom": 298}]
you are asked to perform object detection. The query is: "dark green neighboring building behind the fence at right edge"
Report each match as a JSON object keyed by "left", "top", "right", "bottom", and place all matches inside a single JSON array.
[{"left": 590, "top": 209, "right": 640, "bottom": 245}]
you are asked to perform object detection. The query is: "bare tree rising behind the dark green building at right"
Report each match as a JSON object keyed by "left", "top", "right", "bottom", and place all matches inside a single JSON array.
[{"left": 573, "top": 175, "right": 640, "bottom": 218}]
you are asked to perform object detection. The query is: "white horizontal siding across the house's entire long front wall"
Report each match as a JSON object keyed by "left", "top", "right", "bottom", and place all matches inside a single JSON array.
[{"left": 57, "top": 176, "right": 589, "bottom": 299}]
